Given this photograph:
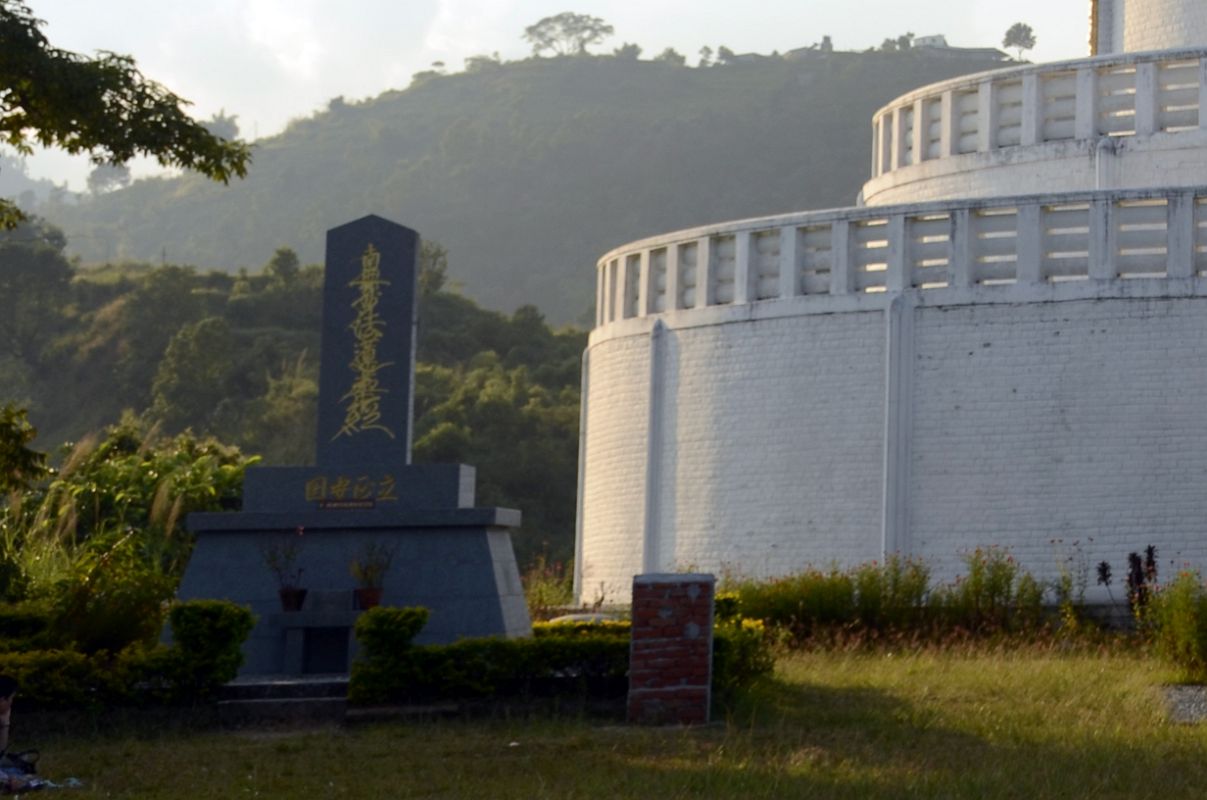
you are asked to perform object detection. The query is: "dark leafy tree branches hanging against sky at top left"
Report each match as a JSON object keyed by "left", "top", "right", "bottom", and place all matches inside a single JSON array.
[{"left": 0, "top": 0, "right": 251, "bottom": 227}]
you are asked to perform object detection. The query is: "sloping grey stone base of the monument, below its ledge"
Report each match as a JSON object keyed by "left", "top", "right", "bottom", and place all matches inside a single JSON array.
[{"left": 179, "top": 526, "right": 532, "bottom": 676}]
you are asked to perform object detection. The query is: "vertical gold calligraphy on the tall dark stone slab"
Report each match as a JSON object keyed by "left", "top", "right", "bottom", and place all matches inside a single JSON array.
[{"left": 332, "top": 244, "right": 395, "bottom": 440}]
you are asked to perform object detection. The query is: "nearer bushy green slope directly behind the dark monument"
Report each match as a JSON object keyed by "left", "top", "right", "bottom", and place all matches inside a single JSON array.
[{"left": 0, "top": 221, "right": 585, "bottom": 562}]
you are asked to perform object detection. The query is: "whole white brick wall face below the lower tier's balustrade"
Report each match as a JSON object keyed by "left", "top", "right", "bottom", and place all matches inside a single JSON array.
[{"left": 582, "top": 297, "right": 1207, "bottom": 601}]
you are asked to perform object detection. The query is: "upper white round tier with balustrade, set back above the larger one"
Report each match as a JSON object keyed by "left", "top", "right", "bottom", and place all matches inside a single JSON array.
[{"left": 861, "top": 50, "right": 1207, "bottom": 205}]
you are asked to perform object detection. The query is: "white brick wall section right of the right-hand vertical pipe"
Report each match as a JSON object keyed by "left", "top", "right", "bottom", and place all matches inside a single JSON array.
[{"left": 910, "top": 298, "right": 1207, "bottom": 583}]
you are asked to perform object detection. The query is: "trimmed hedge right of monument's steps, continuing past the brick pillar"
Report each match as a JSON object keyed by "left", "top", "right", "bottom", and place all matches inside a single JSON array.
[{"left": 348, "top": 608, "right": 774, "bottom": 705}]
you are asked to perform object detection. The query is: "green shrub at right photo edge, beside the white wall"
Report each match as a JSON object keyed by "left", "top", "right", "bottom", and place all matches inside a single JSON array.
[{"left": 1148, "top": 572, "right": 1207, "bottom": 683}]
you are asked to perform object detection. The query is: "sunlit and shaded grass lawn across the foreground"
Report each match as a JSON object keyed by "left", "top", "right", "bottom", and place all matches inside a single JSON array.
[{"left": 23, "top": 652, "right": 1207, "bottom": 800}]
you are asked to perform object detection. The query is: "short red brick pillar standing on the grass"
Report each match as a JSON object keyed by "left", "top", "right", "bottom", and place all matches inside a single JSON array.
[{"left": 629, "top": 574, "right": 716, "bottom": 725}]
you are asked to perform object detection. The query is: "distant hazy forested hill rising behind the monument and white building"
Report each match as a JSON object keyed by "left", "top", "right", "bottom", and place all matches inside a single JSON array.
[{"left": 40, "top": 49, "right": 1002, "bottom": 322}]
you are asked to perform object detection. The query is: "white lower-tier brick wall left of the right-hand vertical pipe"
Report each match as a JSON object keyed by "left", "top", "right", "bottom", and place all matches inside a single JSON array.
[{"left": 582, "top": 311, "right": 885, "bottom": 600}]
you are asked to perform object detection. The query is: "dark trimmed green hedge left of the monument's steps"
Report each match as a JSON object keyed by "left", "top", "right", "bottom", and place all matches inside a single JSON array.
[{"left": 0, "top": 600, "right": 253, "bottom": 710}]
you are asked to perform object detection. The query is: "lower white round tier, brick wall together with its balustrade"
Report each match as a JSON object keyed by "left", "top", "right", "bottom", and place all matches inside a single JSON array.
[{"left": 576, "top": 188, "right": 1207, "bottom": 602}]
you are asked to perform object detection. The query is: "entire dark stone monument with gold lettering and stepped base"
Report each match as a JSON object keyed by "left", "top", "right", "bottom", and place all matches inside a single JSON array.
[{"left": 179, "top": 216, "right": 532, "bottom": 675}]
